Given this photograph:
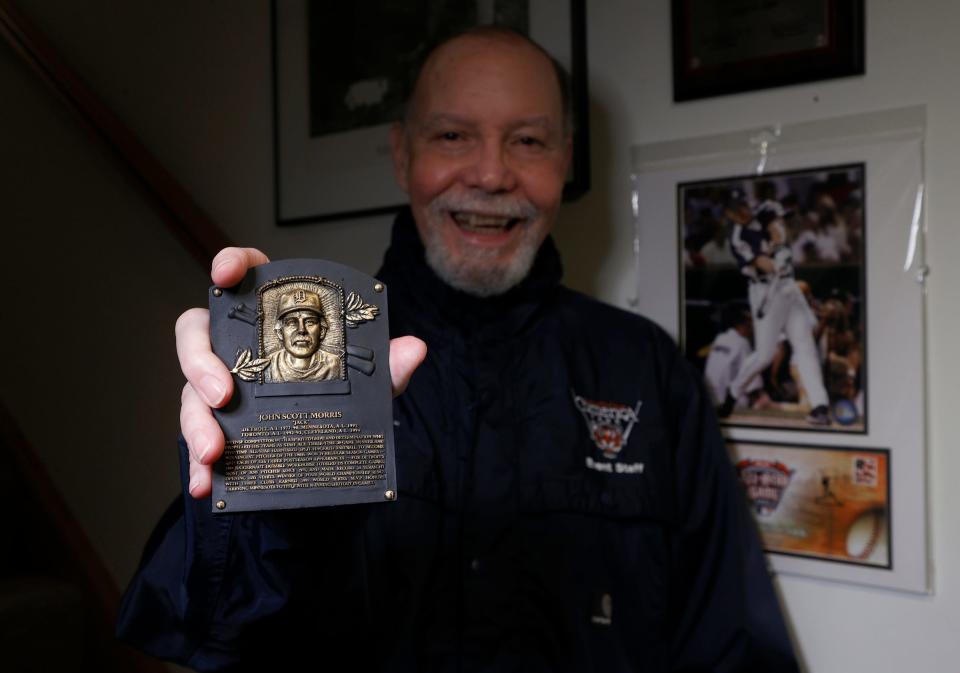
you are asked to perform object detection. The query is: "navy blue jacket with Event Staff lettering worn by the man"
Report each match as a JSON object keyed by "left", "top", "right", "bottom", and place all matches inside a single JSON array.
[{"left": 118, "top": 212, "right": 796, "bottom": 673}]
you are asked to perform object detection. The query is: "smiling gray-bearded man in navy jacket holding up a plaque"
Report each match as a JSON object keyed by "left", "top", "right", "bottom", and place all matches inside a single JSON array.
[{"left": 119, "top": 29, "right": 796, "bottom": 672}]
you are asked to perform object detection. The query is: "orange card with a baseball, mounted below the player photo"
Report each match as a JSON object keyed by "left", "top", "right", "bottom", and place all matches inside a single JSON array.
[{"left": 729, "top": 442, "right": 893, "bottom": 570}]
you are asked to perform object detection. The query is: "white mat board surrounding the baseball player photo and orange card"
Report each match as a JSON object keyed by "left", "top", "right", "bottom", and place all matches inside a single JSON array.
[{"left": 623, "top": 105, "right": 932, "bottom": 594}]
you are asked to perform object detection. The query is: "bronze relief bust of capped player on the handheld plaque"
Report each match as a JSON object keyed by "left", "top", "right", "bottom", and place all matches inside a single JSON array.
[{"left": 263, "top": 289, "right": 342, "bottom": 383}]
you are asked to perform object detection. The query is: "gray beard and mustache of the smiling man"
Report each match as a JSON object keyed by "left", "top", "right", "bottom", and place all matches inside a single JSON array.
[{"left": 423, "top": 192, "right": 540, "bottom": 298}]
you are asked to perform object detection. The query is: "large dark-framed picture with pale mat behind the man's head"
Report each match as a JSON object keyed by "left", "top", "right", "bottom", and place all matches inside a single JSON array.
[{"left": 273, "top": 0, "right": 590, "bottom": 225}]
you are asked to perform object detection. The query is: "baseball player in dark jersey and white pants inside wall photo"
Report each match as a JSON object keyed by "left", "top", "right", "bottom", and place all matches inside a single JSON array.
[{"left": 717, "top": 189, "right": 830, "bottom": 426}]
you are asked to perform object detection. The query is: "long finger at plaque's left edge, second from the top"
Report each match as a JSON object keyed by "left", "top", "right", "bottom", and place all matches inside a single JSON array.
[{"left": 175, "top": 308, "right": 233, "bottom": 407}]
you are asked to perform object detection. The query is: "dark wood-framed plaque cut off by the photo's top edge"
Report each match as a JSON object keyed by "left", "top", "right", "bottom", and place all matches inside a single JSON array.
[{"left": 672, "top": 0, "right": 864, "bottom": 102}]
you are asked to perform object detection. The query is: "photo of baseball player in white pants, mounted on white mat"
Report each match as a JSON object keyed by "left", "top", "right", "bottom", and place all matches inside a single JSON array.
[{"left": 677, "top": 163, "right": 868, "bottom": 433}]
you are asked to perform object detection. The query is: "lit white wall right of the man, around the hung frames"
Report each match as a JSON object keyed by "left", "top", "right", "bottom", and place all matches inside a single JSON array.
[{"left": 576, "top": 0, "right": 960, "bottom": 673}]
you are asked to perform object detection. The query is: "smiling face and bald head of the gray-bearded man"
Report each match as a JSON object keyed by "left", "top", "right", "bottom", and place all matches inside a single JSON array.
[{"left": 391, "top": 34, "right": 570, "bottom": 296}]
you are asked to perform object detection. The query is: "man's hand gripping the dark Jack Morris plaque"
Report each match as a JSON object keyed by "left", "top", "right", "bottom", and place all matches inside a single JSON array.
[{"left": 176, "top": 248, "right": 427, "bottom": 498}]
